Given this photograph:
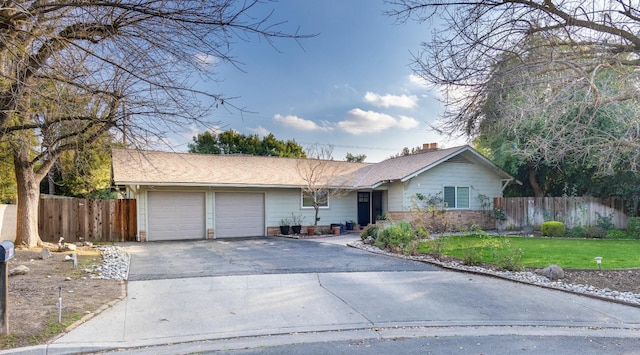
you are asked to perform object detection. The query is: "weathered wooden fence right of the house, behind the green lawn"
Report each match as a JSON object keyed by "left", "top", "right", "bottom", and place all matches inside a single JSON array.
[{"left": 493, "top": 196, "right": 627, "bottom": 230}]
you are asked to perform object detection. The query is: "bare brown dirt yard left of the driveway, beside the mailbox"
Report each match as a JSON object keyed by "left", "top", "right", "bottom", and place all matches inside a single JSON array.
[{"left": 0, "top": 247, "right": 124, "bottom": 349}]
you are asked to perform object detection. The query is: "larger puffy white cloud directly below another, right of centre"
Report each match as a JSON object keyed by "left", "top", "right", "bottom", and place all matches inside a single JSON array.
[{"left": 338, "top": 108, "right": 420, "bottom": 135}]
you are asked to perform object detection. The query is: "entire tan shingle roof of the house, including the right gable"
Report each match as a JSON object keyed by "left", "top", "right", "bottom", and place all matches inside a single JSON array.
[{"left": 112, "top": 145, "right": 512, "bottom": 188}]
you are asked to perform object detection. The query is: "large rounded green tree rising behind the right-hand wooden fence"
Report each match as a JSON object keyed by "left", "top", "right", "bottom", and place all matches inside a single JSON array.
[{"left": 469, "top": 40, "right": 640, "bottom": 197}]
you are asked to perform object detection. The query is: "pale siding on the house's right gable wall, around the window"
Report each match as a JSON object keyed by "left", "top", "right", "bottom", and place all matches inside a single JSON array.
[{"left": 404, "top": 163, "right": 502, "bottom": 210}]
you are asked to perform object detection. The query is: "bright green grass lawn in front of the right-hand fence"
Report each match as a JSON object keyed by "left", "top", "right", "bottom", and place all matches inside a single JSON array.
[{"left": 418, "top": 236, "right": 640, "bottom": 269}]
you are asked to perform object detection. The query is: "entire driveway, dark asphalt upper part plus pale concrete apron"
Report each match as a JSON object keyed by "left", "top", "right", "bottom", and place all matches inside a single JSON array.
[{"left": 46, "top": 238, "right": 640, "bottom": 354}]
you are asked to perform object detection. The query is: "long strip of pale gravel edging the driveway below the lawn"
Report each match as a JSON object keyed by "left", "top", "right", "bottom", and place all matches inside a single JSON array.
[{"left": 349, "top": 241, "right": 640, "bottom": 306}]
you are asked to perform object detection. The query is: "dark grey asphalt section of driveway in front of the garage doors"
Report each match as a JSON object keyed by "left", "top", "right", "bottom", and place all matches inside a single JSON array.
[{"left": 123, "top": 236, "right": 439, "bottom": 281}]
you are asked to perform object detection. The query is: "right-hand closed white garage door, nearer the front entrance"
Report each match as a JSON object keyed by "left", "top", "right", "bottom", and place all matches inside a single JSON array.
[{"left": 215, "top": 192, "right": 264, "bottom": 238}]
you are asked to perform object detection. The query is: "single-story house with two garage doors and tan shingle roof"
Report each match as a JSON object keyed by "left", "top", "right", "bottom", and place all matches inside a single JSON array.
[{"left": 112, "top": 144, "right": 513, "bottom": 241}]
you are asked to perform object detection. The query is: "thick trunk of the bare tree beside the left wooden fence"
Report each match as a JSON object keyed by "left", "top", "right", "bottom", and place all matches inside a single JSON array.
[{"left": 13, "top": 153, "right": 42, "bottom": 248}]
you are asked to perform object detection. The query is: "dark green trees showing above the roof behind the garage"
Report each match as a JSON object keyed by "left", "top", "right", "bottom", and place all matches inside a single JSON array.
[{"left": 189, "top": 130, "right": 306, "bottom": 158}]
